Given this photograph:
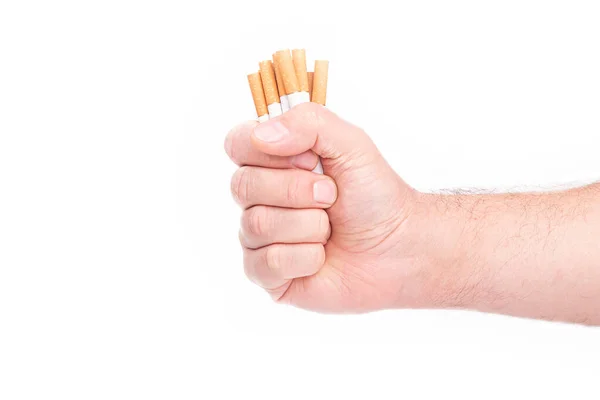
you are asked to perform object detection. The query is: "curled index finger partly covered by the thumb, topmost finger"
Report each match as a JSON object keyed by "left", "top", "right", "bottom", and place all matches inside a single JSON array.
[{"left": 225, "top": 121, "right": 318, "bottom": 171}]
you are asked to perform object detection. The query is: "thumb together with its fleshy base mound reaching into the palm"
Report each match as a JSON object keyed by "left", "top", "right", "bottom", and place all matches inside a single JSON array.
[{"left": 250, "top": 103, "right": 412, "bottom": 249}]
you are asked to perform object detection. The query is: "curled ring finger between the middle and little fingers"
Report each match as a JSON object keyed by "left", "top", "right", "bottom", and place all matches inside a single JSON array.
[{"left": 240, "top": 206, "right": 330, "bottom": 249}]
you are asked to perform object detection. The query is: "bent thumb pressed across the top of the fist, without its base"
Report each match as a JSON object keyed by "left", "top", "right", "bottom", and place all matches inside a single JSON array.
[{"left": 251, "top": 103, "right": 377, "bottom": 164}]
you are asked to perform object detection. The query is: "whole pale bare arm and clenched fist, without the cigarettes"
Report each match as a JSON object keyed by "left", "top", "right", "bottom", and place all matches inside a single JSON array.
[{"left": 225, "top": 103, "right": 600, "bottom": 325}]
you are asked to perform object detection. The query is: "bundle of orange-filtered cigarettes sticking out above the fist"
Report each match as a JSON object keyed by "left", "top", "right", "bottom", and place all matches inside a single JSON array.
[{"left": 248, "top": 49, "right": 329, "bottom": 122}]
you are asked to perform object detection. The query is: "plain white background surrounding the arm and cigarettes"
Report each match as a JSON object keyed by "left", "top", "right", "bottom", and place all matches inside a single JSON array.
[{"left": 0, "top": 0, "right": 600, "bottom": 400}]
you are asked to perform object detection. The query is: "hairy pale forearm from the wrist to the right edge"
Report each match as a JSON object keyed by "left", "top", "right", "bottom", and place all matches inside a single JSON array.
[{"left": 424, "top": 185, "right": 600, "bottom": 324}]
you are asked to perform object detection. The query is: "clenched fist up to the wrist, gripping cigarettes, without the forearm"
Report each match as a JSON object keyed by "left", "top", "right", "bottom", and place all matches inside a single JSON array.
[{"left": 225, "top": 103, "right": 458, "bottom": 312}]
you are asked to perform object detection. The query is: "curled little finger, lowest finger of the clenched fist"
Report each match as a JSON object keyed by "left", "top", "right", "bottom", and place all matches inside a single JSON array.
[{"left": 244, "top": 243, "right": 325, "bottom": 289}]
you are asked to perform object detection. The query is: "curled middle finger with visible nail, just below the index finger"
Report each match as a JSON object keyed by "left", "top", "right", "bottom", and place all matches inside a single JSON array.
[{"left": 231, "top": 167, "right": 337, "bottom": 208}]
